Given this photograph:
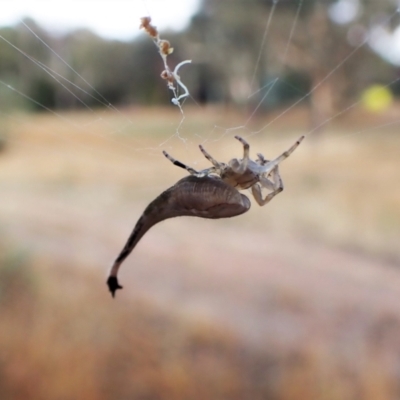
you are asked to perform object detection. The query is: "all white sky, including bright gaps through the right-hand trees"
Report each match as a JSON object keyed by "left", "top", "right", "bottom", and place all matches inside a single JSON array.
[{"left": 0, "top": 0, "right": 400, "bottom": 65}]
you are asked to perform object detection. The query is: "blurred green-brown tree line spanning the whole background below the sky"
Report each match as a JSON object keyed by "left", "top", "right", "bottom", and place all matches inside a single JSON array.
[{"left": 0, "top": 0, "right": 398, "bottom": 118}]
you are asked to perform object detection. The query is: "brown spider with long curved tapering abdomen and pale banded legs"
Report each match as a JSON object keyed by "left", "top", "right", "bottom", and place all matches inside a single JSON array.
[{"left": 107, "top": 136, "right": 304, "bottom": 297}]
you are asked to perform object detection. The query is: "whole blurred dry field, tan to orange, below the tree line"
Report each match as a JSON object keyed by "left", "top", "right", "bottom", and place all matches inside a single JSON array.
[{"left": 0, "top": 104, "right": 400, "bottom": 400}]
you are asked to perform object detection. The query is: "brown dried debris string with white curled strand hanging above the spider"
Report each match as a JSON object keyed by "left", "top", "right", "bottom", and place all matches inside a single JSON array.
[{"left": 140, "top": 17, "right": 192, "bottom": 108}]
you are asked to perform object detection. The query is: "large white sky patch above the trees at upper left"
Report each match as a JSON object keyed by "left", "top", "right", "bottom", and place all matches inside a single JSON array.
[{"left": 0, "top": 0, "right": 200, "bottom": 40}]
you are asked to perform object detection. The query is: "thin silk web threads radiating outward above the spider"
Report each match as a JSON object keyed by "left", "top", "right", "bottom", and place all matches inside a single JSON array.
[{"left": 0, "top": 0, "right": 400, "bottom": 154}]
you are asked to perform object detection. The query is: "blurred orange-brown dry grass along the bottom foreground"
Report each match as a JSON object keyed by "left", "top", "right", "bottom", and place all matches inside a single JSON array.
[{"left": 0, "top": 244, "right": 400, "bottom": 400}]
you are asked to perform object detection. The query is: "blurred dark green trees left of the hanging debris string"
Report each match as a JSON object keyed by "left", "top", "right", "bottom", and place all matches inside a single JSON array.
[{"left": 0, "top": 20, "right": 173, "bottom": 110}]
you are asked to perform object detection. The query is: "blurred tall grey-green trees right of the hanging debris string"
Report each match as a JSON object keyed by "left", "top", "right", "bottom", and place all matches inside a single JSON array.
[{"left": 188, "top": 0, "right": 395, "bottom": 129}]
